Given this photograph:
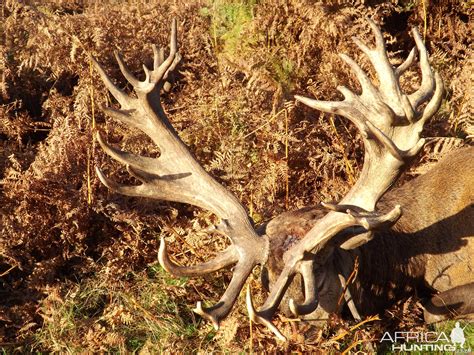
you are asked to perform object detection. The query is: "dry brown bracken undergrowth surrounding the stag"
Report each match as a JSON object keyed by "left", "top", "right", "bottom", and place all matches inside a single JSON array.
[{"left": 0, "top": 0, "right": 474, "bottom": 353}]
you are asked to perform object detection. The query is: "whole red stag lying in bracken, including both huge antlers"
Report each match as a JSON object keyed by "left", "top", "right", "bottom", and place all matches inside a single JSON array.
[{"left": 94, "top": 20, "right": 474, "bottom": 339}]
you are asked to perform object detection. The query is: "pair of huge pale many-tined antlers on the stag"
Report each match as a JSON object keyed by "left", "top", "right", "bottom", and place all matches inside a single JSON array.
[{"left": 93, "top": 20, "right": 443, "bottom": 339}]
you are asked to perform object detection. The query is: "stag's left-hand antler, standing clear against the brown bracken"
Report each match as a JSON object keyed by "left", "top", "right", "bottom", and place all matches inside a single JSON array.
[{"left": 92, "top": 21, "right": 268, "bottom": 329}]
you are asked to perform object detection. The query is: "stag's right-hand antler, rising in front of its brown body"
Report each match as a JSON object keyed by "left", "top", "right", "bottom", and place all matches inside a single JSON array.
[{"left": 247, "top": 20, "right": 443, "bottom": 339}]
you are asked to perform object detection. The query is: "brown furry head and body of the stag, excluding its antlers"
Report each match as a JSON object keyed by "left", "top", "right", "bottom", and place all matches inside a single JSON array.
[{"left": 265, "top": 147, "right": 474, "bottom": 320}]
